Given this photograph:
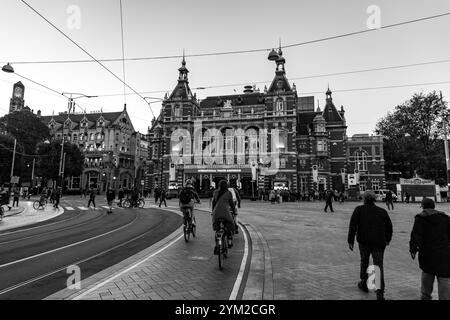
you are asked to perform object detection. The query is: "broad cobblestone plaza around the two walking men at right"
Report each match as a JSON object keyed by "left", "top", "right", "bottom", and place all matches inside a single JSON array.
[{"left": 236, "top": 201, "right": 450, "bottom": 300}]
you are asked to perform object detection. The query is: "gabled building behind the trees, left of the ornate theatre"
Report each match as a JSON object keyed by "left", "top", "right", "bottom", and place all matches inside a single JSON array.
[{"left": 41, "top": 107, "right": 148, "bottom": 192}]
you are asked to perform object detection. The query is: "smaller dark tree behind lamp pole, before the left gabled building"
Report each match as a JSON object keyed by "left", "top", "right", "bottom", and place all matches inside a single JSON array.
[{"left": 37, "top": 140, "right": 84, "bottom": 180}]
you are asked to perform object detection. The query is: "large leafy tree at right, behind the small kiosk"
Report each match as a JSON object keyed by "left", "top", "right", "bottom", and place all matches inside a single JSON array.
[{"left": 375, "top": 91, "right": 449, "bottom": 185}]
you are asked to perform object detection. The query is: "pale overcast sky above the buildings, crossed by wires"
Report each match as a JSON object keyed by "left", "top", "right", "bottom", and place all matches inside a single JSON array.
[{"left": 0, "top": 0, "right": 450, "bottom": 135}]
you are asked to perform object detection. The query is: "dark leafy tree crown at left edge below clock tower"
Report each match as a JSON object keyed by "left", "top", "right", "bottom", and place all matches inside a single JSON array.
[{"left": 0, "top": 110, "right": 50, "bottom": 155}]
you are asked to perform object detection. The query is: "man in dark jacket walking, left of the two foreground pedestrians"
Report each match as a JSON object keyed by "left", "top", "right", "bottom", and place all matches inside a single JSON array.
[{"left": 347, "top": 191, "right": 392, "bottom": 300}]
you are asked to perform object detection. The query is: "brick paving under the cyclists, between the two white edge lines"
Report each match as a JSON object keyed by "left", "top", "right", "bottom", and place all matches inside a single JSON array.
[{"left": 61, "top": 205, "right": 244, "bottom": 300}]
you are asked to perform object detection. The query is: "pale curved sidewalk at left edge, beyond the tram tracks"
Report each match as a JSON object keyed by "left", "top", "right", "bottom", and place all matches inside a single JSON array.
[{"left": 0, "top": 201, "right": 64, "bottom": 232}]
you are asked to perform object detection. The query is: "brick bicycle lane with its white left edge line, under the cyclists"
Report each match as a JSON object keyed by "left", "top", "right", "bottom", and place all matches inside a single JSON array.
[{"left": 47, "top": 205, "right": 245, "bottom": 300}]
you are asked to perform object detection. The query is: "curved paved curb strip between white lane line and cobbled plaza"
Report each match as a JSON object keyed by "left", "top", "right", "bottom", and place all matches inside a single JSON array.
[{"left": 242, "top": 222, "right": 274, "bottom": 300}]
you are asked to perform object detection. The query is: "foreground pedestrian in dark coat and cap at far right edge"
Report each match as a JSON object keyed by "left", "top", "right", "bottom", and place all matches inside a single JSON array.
[{"left": 409, "top": 198, "right": 450, "bottom": 300}]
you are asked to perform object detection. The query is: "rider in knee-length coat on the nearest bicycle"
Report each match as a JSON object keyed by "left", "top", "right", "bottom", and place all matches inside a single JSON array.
[{"left": 212, "top": 180, "right": 236, "bottom": 250}]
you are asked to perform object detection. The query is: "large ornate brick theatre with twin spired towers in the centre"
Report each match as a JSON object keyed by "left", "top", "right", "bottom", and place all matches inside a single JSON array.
[{"left": 148, "top": 48, "right": 384, "bottom": 197}]
